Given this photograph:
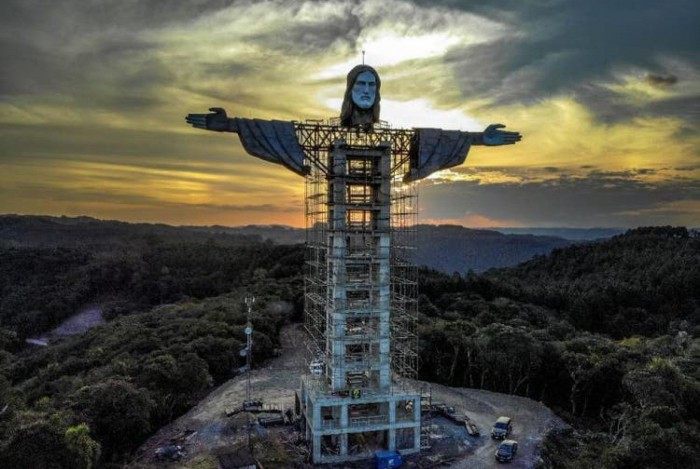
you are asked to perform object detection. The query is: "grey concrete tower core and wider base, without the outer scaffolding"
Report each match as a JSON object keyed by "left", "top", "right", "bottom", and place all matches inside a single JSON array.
[{"left": 300, "top": 141, "right": 420, "bottom": 463}]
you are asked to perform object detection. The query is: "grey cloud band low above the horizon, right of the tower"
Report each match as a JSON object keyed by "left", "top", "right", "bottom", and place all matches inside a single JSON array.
[{"left": 421, "top": 171, "right": 700, "bottom": 226}]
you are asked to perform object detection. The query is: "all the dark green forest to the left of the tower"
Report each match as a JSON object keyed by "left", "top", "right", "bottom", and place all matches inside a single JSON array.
[{"left": 0, "top": 232, "right": 303, "bottom": 462}]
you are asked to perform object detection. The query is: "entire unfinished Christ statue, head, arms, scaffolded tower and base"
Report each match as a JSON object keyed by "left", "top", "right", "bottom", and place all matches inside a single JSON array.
[{"left": 186, "top": 65, "right": 520, "bottom": 463}]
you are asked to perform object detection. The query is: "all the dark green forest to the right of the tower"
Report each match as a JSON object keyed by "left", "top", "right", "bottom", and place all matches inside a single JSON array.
[{"left": 419, "top": 228, "right": 700, "bottom": 468}]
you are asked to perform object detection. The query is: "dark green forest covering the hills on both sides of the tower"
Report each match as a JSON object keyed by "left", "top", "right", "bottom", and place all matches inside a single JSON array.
[{"left": 0, "top": 221, "right": 700, "bottom": 468}]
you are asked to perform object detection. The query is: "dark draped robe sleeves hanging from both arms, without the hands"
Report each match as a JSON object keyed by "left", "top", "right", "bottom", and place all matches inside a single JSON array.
[{"left": 233, "top": 118, "right": 472, "bottom": 181}]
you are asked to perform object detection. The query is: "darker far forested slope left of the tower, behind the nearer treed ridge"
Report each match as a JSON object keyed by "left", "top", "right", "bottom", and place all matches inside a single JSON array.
[{"left": 0, "top": 237, "right": 303, "bottom": 342}]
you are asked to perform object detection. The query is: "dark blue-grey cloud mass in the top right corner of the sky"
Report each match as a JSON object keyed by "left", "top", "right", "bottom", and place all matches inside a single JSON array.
[{"left": 430, "top": 0, "right": 700, "bottom": 120}]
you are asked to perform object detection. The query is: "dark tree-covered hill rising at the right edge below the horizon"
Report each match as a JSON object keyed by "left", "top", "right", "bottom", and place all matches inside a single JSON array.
[{"left": 486, "top": 227, "right": 700, "bottom": 337}]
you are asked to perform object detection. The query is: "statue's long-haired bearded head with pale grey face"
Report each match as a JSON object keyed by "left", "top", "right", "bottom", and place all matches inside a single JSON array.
[{"left": 340, "top": 65, "right": 381, "bottom": 127}]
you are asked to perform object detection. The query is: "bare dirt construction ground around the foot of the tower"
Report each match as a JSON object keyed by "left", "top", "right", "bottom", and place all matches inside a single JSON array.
[{"left": 129, "top": 324, "right": 565, "bottom": 469}]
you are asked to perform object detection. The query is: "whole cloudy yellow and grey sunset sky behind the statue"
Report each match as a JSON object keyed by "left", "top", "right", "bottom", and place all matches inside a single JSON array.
[{"left": 0, "top": 0, "right": 700, "bottom": 227}]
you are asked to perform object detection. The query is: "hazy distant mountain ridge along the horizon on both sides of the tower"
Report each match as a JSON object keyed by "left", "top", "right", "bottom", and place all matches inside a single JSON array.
[{"left": 0, "top": 215, "right": 572, "bottom": 274}]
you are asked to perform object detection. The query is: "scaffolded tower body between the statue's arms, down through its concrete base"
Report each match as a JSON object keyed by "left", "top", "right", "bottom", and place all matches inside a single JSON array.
[{"left": 295, "top": 121, "right": 421, "bottom": 463}]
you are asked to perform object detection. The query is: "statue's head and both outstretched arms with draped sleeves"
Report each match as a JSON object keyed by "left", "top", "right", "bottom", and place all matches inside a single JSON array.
[{"left": 185, "top": 64, "right": 521, "bottom": 181}]
